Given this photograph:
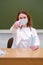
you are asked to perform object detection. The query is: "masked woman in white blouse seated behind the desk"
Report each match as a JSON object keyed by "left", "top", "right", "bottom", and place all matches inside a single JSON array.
[{"left": 10, "top": 11, "right": 40, "bottom": 50}]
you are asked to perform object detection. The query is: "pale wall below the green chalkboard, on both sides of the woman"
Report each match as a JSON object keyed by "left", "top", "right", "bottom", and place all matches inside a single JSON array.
[{"left": 0, "top": 30, "right": 43, "bottom": 48}]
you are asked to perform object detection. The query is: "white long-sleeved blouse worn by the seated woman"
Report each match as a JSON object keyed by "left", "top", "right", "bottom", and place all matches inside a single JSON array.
[{"left": 10, "top": 26, "right": 40, "bottom": 48}]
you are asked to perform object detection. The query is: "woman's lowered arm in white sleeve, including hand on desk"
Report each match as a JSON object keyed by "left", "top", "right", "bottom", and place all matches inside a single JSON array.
[{"left": 30, "top": 29, "right": 40, "bottom": 50}]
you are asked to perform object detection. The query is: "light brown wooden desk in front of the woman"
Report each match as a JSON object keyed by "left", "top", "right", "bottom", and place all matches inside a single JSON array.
[{"left": 0, "top": 48, "right": 43, "bottom": 65}]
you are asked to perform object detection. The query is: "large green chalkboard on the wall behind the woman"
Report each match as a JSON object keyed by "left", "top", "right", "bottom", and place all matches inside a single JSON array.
[{"left": 0, "top": 0, "right": 43, "bottom": 29}]
